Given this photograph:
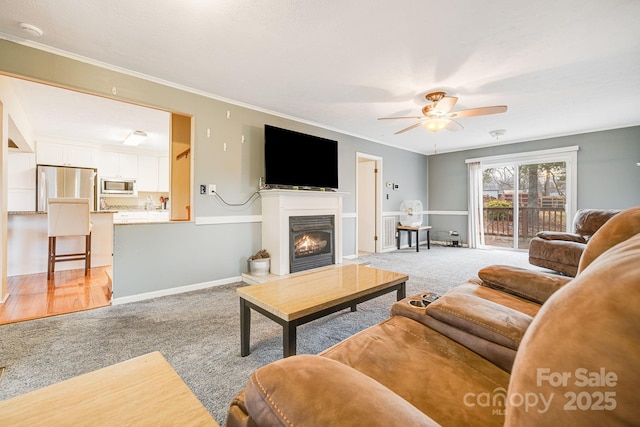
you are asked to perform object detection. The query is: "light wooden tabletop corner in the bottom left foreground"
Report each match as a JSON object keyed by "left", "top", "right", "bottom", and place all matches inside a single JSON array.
[{"left": 0, "top": 352, "right": 218, "bottom": 427}]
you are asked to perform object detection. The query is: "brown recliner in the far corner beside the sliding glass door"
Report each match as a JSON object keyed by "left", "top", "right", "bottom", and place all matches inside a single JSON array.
[{"left": 529, "top": 209, "right": 620, "bottom": 277}]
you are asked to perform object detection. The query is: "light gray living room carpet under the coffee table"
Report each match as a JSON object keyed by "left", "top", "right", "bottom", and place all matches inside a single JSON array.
[{"left": 0, "top": 246, "right": 537, "bottom": 425}]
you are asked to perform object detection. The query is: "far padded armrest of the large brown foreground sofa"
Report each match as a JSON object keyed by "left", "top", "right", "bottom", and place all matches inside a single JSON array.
[{"left": 478, "top": 265, "right": 572, "bottom": 304}]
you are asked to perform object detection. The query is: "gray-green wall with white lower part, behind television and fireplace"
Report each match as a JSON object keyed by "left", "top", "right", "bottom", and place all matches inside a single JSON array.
[{"left": 0, "top": 40, "right": 428, "bottom": 298}]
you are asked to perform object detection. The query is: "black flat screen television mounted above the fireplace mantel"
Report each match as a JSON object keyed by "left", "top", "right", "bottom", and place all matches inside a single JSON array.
[{"left": 264, "top": 125, "right": 338, "bottom": 190}]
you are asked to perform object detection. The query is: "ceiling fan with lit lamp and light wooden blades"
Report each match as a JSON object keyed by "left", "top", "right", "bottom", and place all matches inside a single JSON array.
[{"left": 378, "top": 92, "right": 507, "bottom": 135}]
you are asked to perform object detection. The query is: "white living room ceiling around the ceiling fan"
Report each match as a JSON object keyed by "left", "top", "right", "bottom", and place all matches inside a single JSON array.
[{"left": 0, "top": 0, "right": 640, "bottom": 154}]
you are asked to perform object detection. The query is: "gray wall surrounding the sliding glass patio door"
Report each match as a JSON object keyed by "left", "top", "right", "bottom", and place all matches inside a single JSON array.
[{"left": 429, "top": 126, "right": 640, "bottom": 242}]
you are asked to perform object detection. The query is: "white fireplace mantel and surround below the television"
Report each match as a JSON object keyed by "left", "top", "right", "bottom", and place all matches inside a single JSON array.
[{"left": 260, "top": 190, "right": 348, "bottom": 276}]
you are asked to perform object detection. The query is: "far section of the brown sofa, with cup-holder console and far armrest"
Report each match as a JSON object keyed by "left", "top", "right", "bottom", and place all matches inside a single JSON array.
[{"left": 391, "top": 207, "right": 640, "bottom": 372}]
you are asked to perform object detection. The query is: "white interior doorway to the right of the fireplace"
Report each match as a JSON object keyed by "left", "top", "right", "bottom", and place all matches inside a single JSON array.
[{"left": 356, "top": 153, "right": 382, "bottom": 255}]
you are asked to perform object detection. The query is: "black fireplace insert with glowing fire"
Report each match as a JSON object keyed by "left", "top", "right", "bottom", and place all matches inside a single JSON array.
[{"left": 289, "top": 215, "right": 335, "bottom": 273}]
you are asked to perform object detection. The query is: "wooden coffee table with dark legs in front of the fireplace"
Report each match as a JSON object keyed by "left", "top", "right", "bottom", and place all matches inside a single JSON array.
[{"left": 237, "top": 264, "right": 409, "bottom": 357}]
